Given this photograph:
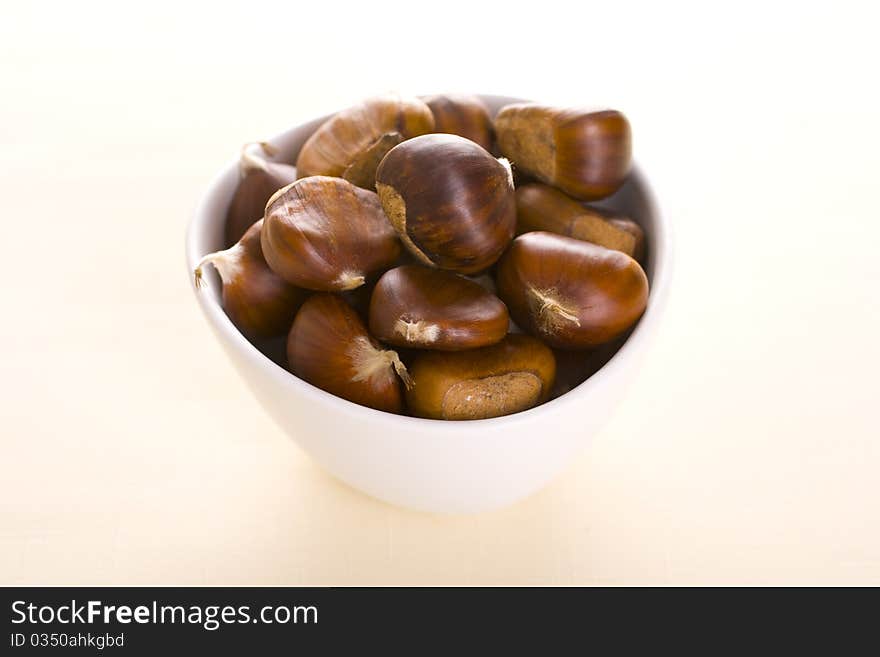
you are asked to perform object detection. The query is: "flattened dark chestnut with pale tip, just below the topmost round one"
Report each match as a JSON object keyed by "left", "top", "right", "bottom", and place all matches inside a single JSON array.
[{"left": 370, "top": 265, "right": 510, "bottom": 351}]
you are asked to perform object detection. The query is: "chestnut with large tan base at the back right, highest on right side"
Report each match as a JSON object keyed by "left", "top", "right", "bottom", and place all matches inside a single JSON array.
[{"left": 495, "top": 103, "right": 632, "bottom": 201}]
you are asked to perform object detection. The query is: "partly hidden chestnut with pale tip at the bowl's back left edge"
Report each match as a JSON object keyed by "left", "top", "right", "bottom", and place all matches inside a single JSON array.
[{"left": 226, "top": 142, "right": 296, "bottom": 247}]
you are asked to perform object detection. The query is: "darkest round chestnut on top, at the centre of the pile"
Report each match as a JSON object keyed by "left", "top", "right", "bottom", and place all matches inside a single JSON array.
[{"left": 376, "top": 134, "right": 516, "bottom": 274}]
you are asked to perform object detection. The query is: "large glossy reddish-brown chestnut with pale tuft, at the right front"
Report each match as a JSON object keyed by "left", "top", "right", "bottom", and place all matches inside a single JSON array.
[{"left": 496, "top": 232, "right": 648, "bottom": 349}]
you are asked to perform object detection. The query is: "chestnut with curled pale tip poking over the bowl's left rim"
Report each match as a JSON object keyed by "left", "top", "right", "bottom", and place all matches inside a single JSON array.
[{"left": 194, "top": 220, "right": 307, "bottom": 338}]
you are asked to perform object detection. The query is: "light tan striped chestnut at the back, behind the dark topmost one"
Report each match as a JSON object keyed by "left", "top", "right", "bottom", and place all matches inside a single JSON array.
[{"left": 296, "top": 94, "right": 434, "bottom": 189}]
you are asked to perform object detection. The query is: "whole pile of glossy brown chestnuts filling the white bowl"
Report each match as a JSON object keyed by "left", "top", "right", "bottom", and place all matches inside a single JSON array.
[{"left": 201, "top": 95, "right": 648, "bottom": 420}]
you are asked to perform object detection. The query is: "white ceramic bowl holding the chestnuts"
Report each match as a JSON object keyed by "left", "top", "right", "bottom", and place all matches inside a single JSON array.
[{"left": 186, "top": 96, "right": 670, "bottom": 513}]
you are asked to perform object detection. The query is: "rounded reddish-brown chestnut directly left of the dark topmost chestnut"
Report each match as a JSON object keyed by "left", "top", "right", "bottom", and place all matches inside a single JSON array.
[{"left": 262, "top": 176, "right": 400, "bottom": 292}]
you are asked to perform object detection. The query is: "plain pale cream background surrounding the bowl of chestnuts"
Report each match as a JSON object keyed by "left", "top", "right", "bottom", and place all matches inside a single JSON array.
[{"left": 0, "top": 2, "right": 880, "bottom": 584}]
